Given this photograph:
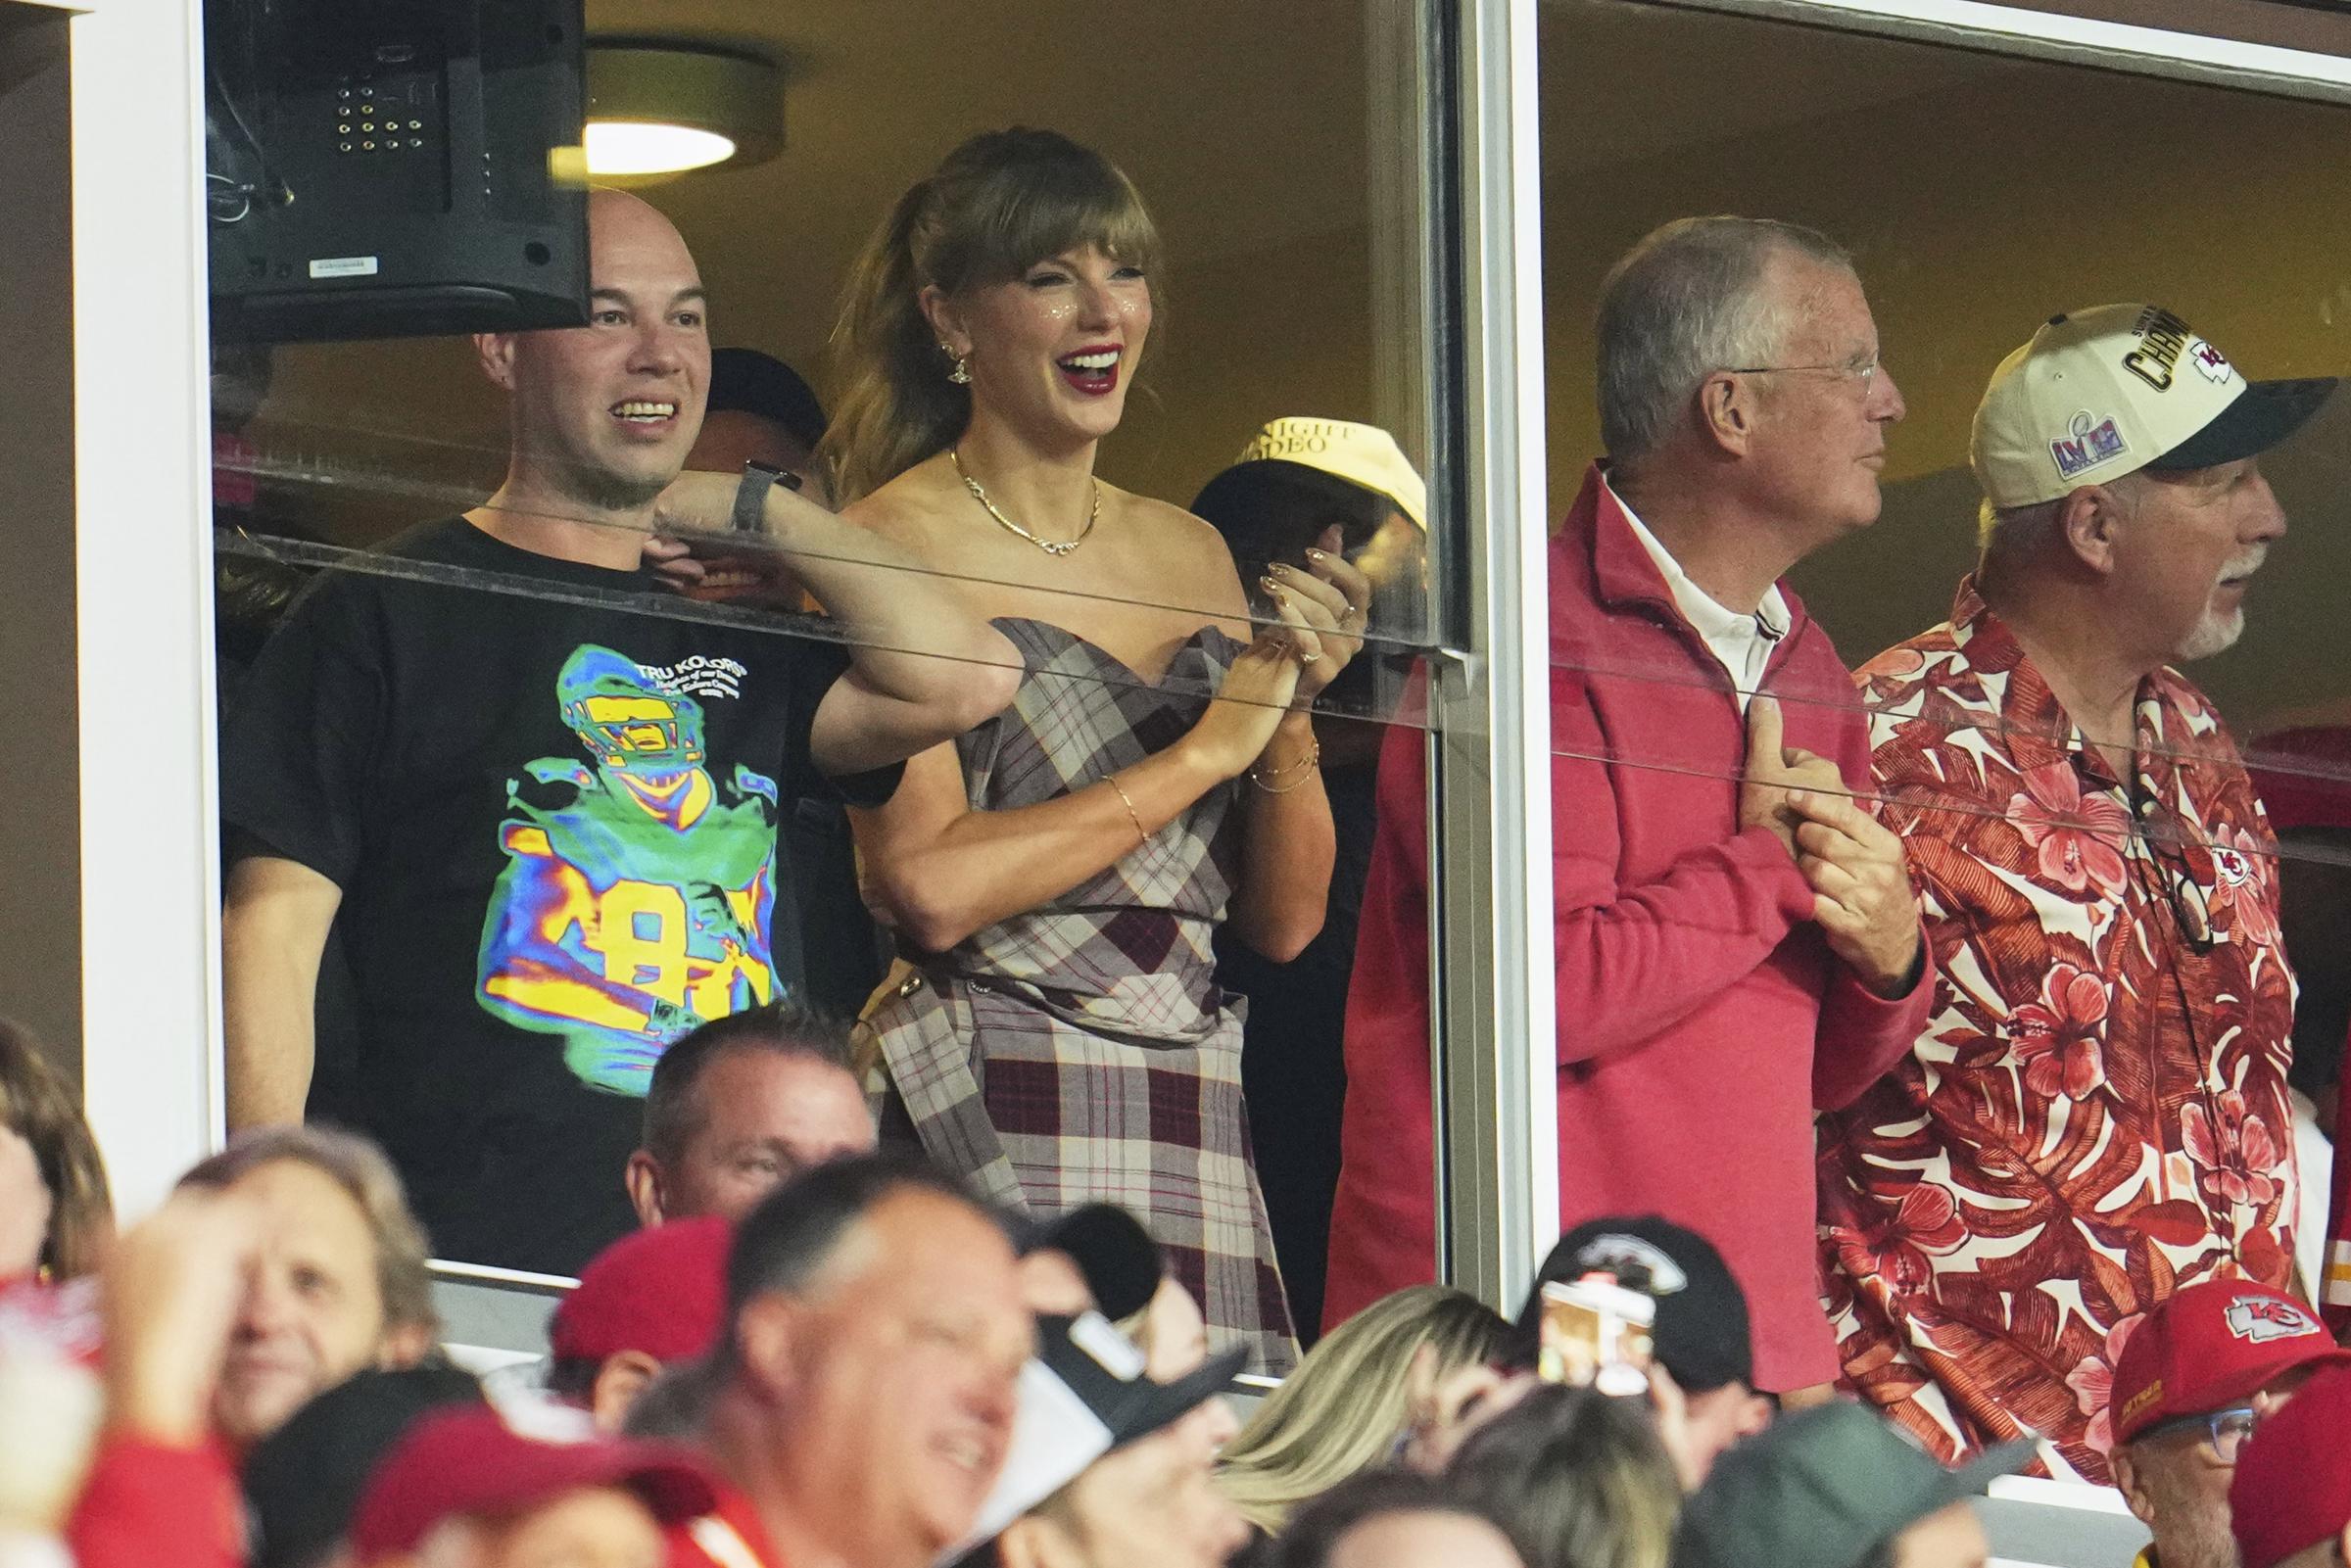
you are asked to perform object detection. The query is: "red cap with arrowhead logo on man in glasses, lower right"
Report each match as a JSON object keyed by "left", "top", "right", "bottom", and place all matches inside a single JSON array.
[{"left": 2106, "top": 1279, "right": 2351, "bottom": 1444}]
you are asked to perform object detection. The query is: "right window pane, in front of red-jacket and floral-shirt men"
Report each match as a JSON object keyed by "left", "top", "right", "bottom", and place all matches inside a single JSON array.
[{"left": 1542, "top": 0, "right": 2351, "bottom": 1481}]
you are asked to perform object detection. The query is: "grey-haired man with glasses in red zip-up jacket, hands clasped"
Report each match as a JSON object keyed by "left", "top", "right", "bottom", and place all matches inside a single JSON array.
[{"left": 1326, "top": 218, "right": 1930, "bottom": 1392}]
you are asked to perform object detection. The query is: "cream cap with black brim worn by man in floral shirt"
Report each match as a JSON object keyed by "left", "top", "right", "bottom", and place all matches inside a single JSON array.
[{"left": 1968, "top": 306, "right": 2334, "bottom": 510}]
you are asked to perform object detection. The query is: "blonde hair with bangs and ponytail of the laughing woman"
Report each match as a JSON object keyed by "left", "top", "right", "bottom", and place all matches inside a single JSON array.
[{"left": 818, "top": 127, "right": 1164, "bottom": 505}]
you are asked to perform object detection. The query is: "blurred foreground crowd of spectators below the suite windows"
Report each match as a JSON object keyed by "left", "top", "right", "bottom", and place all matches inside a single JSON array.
[{"left": 0, "top": 1058, "right": 2351, "bottom": 1568}]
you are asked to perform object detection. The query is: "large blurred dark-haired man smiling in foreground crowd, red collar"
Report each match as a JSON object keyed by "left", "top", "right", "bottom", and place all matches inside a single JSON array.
[{"left": 675, "top": 1155, "right": 1036, "bottom": 1568}]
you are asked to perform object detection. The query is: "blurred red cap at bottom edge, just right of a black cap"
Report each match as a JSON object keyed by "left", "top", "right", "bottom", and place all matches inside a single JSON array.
[{"left": 351, "top": 1405, "right": 717, "bottom": 1563}]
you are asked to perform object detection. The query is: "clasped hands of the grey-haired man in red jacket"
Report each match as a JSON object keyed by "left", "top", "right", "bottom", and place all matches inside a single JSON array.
[{"left": 1740, "top": 693, "right": 1918, "bottom": 997}]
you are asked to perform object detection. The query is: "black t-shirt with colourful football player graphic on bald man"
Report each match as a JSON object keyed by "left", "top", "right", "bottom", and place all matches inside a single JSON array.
[{"left": 221, "top": 517, "right": 898, "bottom": 1274}]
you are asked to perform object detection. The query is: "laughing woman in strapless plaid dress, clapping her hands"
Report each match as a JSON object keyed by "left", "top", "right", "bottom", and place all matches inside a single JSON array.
[{"left": 823, "top": 129, "right": 1370, "bottom": 1373}]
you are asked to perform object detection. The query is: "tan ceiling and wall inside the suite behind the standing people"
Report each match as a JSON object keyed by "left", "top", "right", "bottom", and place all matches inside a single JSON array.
[{"left": 261, "top": 0, "right": 2351, "bottom": 729}]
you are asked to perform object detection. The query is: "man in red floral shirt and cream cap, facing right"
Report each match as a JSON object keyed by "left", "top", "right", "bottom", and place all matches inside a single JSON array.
[{"left": 1820, "top": 306, "right": 2334, "bottom": 1481}]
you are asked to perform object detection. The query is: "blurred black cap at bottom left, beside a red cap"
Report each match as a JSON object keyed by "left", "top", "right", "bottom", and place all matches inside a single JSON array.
[{"left": 242, "top": 1366, "right": 482, "bottom": 1568}]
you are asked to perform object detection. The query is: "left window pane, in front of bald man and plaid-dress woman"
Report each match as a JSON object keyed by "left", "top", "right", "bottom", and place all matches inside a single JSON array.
[{"left": 214, "top": 0, "right": 1458, "bottom": 1366}]
